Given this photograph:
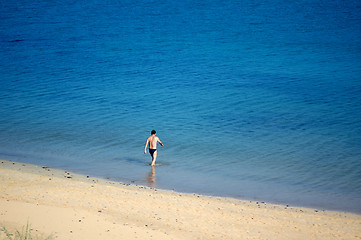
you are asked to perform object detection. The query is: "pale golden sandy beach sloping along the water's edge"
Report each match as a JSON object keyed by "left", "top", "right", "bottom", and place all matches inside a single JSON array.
[{"left": 0, "top": 160, "right": 361, "bottom": 240}]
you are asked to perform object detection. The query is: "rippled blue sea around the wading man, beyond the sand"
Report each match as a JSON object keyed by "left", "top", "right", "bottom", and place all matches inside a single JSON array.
[{"left": 0, "top": 0, "right": 361, "bottom": 213}]
